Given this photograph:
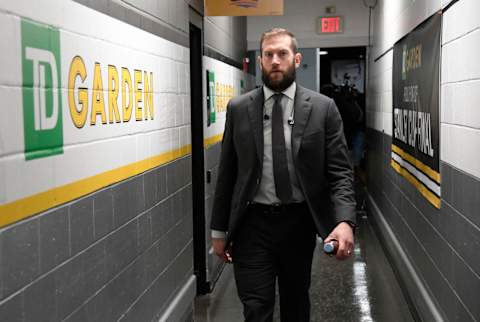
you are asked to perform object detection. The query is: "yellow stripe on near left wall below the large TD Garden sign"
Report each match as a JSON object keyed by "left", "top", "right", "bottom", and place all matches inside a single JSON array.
[{"left": 0, "top": 144, "right": 192, "bottom": 227}]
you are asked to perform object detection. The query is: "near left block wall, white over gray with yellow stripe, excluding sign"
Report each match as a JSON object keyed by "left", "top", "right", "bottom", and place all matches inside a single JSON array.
[{"left": 0, "top": 0, "right": 195, "bottom": 322}]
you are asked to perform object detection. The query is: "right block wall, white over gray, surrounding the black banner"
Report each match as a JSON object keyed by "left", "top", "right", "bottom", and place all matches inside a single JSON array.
[{"left": 367, "top": 0, "right": 480, "bottom": 321}]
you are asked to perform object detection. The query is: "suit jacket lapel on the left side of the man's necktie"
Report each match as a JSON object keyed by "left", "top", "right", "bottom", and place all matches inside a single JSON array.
[{"left": 247, "top": 87, "right": 263, "bottom": 164}]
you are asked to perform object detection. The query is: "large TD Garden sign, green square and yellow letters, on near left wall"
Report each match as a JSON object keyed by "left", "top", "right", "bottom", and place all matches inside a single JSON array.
[{"left": 21, "top": 20, "right": 155, "bottom": 160}]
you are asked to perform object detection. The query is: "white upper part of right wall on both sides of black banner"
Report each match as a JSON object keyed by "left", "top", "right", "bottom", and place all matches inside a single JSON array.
[{"left": 367, "top": 0, "right": 480, "bottom": 178}]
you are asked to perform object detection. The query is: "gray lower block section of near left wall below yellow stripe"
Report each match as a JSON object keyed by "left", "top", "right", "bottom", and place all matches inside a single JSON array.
[{"left": 0, "top": 156, "right": 193, "bottom": 321}]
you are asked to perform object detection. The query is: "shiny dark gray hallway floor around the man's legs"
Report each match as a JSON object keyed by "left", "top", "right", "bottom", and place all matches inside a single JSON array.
[{"left": 194, "top": 217, "right": 413, "bottom": 322}]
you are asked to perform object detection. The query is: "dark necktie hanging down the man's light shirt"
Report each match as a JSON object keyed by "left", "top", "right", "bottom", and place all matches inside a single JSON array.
[{"left": 272, "top": 94, "right": 292, "bottom": 204}]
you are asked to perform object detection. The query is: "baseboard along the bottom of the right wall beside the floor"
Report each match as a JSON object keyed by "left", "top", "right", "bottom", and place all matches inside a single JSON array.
[{"left": 367, "top": 193, "right": 445, "bottom": 322}]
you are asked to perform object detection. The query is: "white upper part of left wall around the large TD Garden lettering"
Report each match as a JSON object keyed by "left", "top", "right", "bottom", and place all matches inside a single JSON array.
[{"left": 0, "top": 0, "right": 190, "bottom": 209}]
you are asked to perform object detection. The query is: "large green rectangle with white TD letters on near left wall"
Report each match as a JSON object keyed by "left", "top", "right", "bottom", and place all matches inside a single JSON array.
[{"left": 21, "top": 20, "right": 63, "bottom": 160}]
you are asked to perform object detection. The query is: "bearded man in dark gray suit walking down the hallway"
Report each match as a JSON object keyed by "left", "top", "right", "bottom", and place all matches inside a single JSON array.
[{"left": 211, "top": 28, "right": 355, "bottom": 322}]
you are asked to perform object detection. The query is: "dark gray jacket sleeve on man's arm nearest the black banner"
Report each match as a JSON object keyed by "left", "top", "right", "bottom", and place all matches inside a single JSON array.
[{"left": 325, "top": 100, "right": 355, "bottom": 223}]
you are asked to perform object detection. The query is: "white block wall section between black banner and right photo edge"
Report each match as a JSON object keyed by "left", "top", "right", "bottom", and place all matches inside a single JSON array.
[{"left": 440, "top": 0, "right": 480, "bottom": 178}]
